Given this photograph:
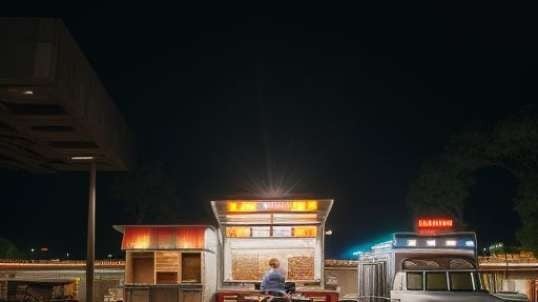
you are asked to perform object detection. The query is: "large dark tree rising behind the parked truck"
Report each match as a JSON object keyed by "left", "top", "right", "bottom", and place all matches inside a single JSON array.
[{"left": 407, "top": 107, "right": 538, "bottom": 252}]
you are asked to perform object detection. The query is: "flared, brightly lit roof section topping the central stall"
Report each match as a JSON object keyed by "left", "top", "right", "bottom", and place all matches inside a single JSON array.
[{"left": 211, "top": 198, "right": 333, "bottom": 225}]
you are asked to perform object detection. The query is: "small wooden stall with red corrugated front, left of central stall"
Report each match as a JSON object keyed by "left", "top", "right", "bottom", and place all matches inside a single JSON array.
[{"left": 116, "top": 225, "right": 219, "bottom": 302}]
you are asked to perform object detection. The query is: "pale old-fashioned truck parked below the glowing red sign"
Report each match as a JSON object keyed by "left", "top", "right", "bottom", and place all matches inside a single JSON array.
[{"left": 358, "top": 232, "right": 503, "bottom": 302}]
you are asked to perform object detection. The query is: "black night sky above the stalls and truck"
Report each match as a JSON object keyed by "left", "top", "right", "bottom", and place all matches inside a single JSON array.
[{"left": 0, "top": 4, "right": 538, "bottom": 257}]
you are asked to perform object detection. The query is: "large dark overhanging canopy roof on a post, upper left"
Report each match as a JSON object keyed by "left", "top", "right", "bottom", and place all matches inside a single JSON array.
[{"left": 0, "top": 18, "right": 134, "bottom": 172}]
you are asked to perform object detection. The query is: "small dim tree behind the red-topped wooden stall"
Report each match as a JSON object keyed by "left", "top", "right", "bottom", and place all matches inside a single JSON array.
[{"left": 112, "top": 161, "right": 179, "bottom": 224}]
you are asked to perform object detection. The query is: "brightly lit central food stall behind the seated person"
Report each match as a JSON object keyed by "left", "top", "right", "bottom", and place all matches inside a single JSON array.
[{"left": 211, "top": 199, "right": 338, "bottom": 302}]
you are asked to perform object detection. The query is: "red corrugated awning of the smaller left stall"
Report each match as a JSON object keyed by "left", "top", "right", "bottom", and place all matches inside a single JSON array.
[{"left": 117, "top": 225, "right": 208, "bottom": 250}]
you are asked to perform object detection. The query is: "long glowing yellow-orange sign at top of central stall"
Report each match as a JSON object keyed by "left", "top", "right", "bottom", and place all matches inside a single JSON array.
[{"left": 226, "top": 200, "right": 318, "bottom": 212}]
